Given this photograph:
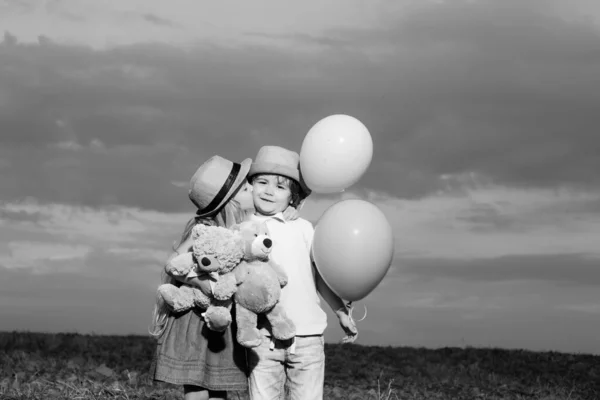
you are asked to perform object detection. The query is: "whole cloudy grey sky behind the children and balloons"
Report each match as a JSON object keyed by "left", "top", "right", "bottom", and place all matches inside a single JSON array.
[{"left": 0, "top": 0, "right": 600, "bottom": 353}]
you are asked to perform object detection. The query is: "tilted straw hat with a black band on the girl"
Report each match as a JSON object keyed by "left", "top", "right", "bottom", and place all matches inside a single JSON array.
[{"left": 188, "top": 156, "right": 252, "bottom": 217}]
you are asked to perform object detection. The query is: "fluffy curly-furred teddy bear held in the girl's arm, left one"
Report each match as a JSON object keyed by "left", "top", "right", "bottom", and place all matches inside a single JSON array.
[{"left": 158, "top": 224, "right": 245, "bottom": 332}]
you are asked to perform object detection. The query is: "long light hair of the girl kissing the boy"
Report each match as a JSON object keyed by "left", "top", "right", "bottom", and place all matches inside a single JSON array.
[{"left": 148, "top": 196, "right": 250, "bottom": 338}]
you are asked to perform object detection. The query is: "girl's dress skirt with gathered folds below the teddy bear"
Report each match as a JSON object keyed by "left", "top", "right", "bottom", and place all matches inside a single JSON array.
[{"left": 150, "top": 305, "right": 248, "bottom": 391}]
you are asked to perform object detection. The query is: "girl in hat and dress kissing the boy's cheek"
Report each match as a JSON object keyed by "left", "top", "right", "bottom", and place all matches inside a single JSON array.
[{"left": 150, "top": 156, "right": 253, "bottom": 400}]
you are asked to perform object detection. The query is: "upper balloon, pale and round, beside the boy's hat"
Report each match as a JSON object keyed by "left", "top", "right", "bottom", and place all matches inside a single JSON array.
[{"left": 300, "top": 114, "right": 373, "bottom": 193}]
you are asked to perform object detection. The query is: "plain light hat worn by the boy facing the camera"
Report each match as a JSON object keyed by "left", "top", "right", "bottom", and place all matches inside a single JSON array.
[{"left": 248, "top": 146, "right": 311, "bottom": 197}]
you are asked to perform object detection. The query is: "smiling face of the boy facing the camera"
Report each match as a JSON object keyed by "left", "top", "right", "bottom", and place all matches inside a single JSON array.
[{"left": 252, "top": 175, "right": 292, "bottom": 215}]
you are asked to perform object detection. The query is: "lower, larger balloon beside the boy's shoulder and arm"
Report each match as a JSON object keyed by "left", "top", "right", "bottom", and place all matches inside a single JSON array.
[{"left": 312, "top": 199, "right": 394, "bottom": 301}]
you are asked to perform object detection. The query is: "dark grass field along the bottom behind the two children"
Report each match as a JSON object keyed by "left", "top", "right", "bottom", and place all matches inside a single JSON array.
[{"left": 0, "top": 332, "right": 600, "bottom": 400}]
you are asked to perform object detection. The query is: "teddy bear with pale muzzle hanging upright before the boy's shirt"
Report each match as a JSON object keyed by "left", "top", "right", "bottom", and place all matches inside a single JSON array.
[{"left": 232, "top": 221, "right": 296, "bottom": 348}]
